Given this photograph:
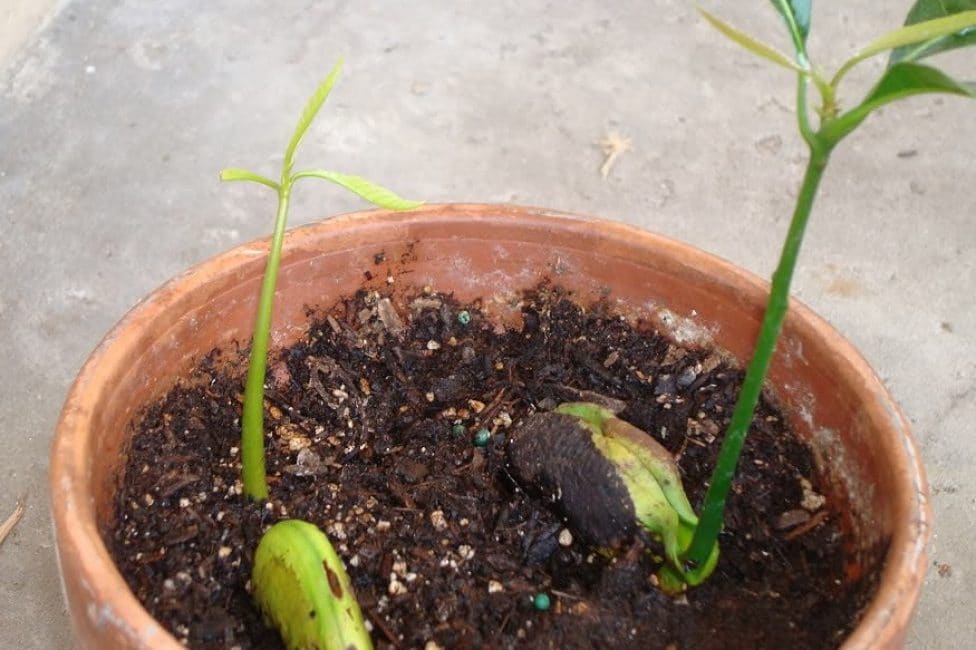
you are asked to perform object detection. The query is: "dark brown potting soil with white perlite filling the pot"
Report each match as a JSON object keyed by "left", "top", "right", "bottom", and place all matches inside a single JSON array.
[{"left": 105, "top": 283, "right": 874, "bottom": 649}]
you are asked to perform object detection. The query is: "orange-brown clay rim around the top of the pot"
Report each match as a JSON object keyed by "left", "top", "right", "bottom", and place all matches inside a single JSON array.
[{"left": 49, "top": 204, "right": 931, "bottom": 649}]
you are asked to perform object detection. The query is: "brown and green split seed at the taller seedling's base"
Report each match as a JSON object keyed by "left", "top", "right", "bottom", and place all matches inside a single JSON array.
[{"left": 509, "top": 402, "right": 718, "bottom": 592}]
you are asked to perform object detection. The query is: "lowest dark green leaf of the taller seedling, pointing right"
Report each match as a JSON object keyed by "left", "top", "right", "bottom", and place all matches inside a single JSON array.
[{"left": 822, "top": 63, "right": 976, "bottom": 142}]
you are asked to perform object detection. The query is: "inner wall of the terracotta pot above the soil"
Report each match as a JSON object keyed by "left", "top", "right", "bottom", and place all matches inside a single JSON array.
[{"left": 91, "top": 208, "right": 898, "bottom": 576}]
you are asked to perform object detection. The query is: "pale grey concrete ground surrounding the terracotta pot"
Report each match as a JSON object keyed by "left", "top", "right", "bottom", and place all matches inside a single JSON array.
[{"left": 0, "top": 0, "right": 976, "bottom": 649}]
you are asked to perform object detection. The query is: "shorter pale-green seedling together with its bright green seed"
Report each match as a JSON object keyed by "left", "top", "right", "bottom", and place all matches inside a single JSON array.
[{"left": 220, "top": 61, "right": 420, "bottom": 650}]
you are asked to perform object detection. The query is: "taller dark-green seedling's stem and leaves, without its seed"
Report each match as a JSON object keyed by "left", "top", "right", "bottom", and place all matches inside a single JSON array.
[{"left": 681, "top": 0, "right": 976, "bottom": 567}]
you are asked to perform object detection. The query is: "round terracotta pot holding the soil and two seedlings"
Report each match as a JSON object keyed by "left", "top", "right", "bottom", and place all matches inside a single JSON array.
[{"left": 50, "top": 205, "right": 931, "bottom": 648}]
